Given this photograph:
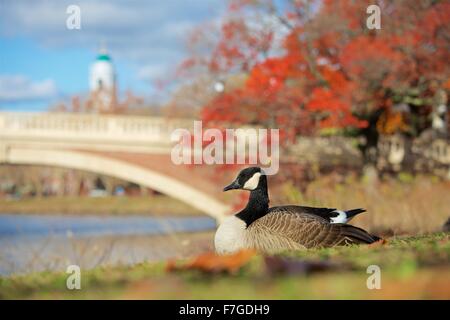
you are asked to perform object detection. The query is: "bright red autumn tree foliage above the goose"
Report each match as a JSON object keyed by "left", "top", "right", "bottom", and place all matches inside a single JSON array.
[{"left": 179, "top": 0, "right": 450, "bottom": 141}]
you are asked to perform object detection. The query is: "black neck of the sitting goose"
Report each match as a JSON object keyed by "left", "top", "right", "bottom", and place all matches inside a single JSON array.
[{"left": 236, "top": 175, "right": 269, "bottom": 227}]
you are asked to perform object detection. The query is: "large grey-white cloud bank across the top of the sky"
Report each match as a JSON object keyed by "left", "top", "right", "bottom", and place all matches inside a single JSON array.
[{"left": 0, "top": 0, "right": 225, "bottom": 84}]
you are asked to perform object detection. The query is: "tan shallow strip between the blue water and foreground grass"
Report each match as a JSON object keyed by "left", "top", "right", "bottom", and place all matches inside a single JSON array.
[{"left": 0, "top": 230, "right": 214, "bottom": 279}]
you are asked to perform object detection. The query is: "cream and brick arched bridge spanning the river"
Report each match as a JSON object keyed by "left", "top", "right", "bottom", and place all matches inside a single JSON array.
[{"left": 0, "top": 112, "right": 237, "bottom": 220}]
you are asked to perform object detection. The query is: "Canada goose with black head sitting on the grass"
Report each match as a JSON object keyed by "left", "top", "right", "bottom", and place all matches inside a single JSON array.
[{"left": 214, "top": 167, "right": 380, "bottom": 254}]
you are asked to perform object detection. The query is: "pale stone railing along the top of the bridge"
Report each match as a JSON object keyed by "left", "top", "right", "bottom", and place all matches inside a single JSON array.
[{"left": 0, "top": 112, "right": 192, "bottom": 142}]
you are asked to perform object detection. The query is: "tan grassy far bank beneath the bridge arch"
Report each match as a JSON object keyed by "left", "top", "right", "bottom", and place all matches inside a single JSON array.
[{"left": 0, "top": 195, "right": 202, "bottom": 215}]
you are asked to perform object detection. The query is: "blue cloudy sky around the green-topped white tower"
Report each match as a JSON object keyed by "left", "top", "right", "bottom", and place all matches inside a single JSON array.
[{"left": 0, "top": 0, "right": 225, "bottom": 111}]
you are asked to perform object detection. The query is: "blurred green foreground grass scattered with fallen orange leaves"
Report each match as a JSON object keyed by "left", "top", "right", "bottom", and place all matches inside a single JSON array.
[{"left": 0, "top": 233, "right": 450, "bottom": 299}]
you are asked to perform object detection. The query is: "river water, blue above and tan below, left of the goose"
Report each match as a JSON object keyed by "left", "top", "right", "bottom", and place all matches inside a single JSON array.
[{"left": 0, "top": 214, "right": 216, "bottom": 275}]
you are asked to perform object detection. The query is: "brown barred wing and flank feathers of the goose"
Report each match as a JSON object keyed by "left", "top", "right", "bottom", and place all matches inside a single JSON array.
[{"left": 247, "top": 206, "right": 378, "bottom": 253}]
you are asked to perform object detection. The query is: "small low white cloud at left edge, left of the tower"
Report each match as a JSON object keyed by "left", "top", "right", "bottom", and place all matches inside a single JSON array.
[{"left": 0, "top": 75, "right": 58, "bottom": 102}]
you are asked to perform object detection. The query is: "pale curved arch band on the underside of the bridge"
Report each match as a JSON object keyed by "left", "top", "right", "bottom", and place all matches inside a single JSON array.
[{"left": 0, "top": 148, "right": 230, "bottom": 221}]
